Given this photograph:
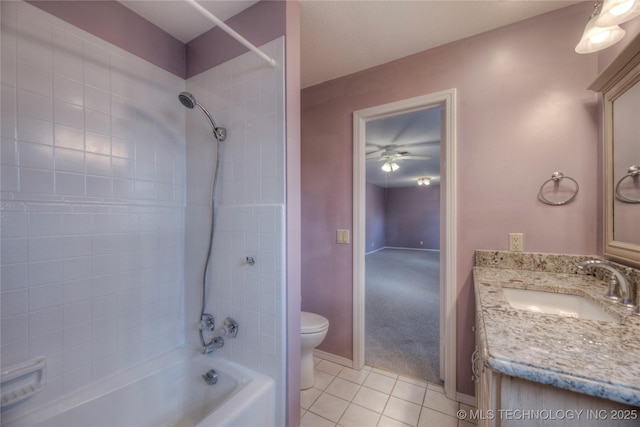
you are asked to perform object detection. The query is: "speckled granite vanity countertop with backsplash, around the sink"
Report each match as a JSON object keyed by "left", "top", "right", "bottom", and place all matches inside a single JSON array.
[{"left": 473, "top": 251, "right": 640, "bottom": 406}]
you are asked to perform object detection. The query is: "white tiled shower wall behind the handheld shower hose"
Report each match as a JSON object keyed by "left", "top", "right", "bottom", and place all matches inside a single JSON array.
[{"left": 185, "top": 38, "right": 286, "bottom": 425}]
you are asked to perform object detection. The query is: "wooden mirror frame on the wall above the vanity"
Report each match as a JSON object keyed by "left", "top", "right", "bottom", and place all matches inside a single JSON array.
[{"left": 589, "top": 34, "right": 640, "bottom": 266}]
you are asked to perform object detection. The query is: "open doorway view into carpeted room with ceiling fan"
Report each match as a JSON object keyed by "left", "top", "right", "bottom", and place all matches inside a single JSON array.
[{"left": 365, "top": 106, "right": 443, "bottom": 383}]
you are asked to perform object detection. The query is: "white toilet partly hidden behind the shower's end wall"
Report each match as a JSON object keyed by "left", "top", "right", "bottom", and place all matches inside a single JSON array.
[{"left": 300, "top": 311, "right": 329, "bottom": 390}]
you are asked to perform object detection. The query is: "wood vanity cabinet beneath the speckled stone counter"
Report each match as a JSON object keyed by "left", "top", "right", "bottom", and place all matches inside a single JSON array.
[{"left": 467, "top": 327, "right": 640, "bottom": 427}]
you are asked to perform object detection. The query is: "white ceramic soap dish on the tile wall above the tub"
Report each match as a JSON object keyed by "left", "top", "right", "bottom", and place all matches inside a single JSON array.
[{"left": 0, "top": 357, "right": 47, "bottom": 408}]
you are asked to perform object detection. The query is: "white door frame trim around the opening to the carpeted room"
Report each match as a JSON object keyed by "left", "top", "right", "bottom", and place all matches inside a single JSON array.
[{"left": 353, "top": 88, "right": 457, "bottom": 400}]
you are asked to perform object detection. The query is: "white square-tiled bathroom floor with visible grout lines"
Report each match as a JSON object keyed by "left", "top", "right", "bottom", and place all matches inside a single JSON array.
[{"left": 301, "top": 358, "right": 475, "bottom": 427}]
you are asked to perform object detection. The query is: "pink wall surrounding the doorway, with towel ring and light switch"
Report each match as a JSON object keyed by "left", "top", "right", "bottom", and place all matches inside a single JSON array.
[{"left": 302, "top": 3, "right": 599, "bottom": 394}]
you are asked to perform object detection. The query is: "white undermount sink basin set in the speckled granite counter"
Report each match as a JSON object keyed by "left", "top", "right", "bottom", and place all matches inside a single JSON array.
[{"left": 502, "top": 288, "right": 618, "bottom": 322}]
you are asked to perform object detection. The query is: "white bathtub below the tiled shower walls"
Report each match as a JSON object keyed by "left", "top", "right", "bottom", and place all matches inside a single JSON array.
[{"left": 2, "top": 347, "right": 275, "bottom": 427}]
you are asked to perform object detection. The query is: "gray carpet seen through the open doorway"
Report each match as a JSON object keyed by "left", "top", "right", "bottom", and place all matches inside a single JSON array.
[{"left": 365, "top": 249, "right": 442, "bottom": 383}]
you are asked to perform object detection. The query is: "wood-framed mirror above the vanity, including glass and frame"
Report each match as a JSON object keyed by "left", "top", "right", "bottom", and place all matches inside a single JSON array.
[{"left": 591, "top": 35, "right": 640, "bottom": 265}]
